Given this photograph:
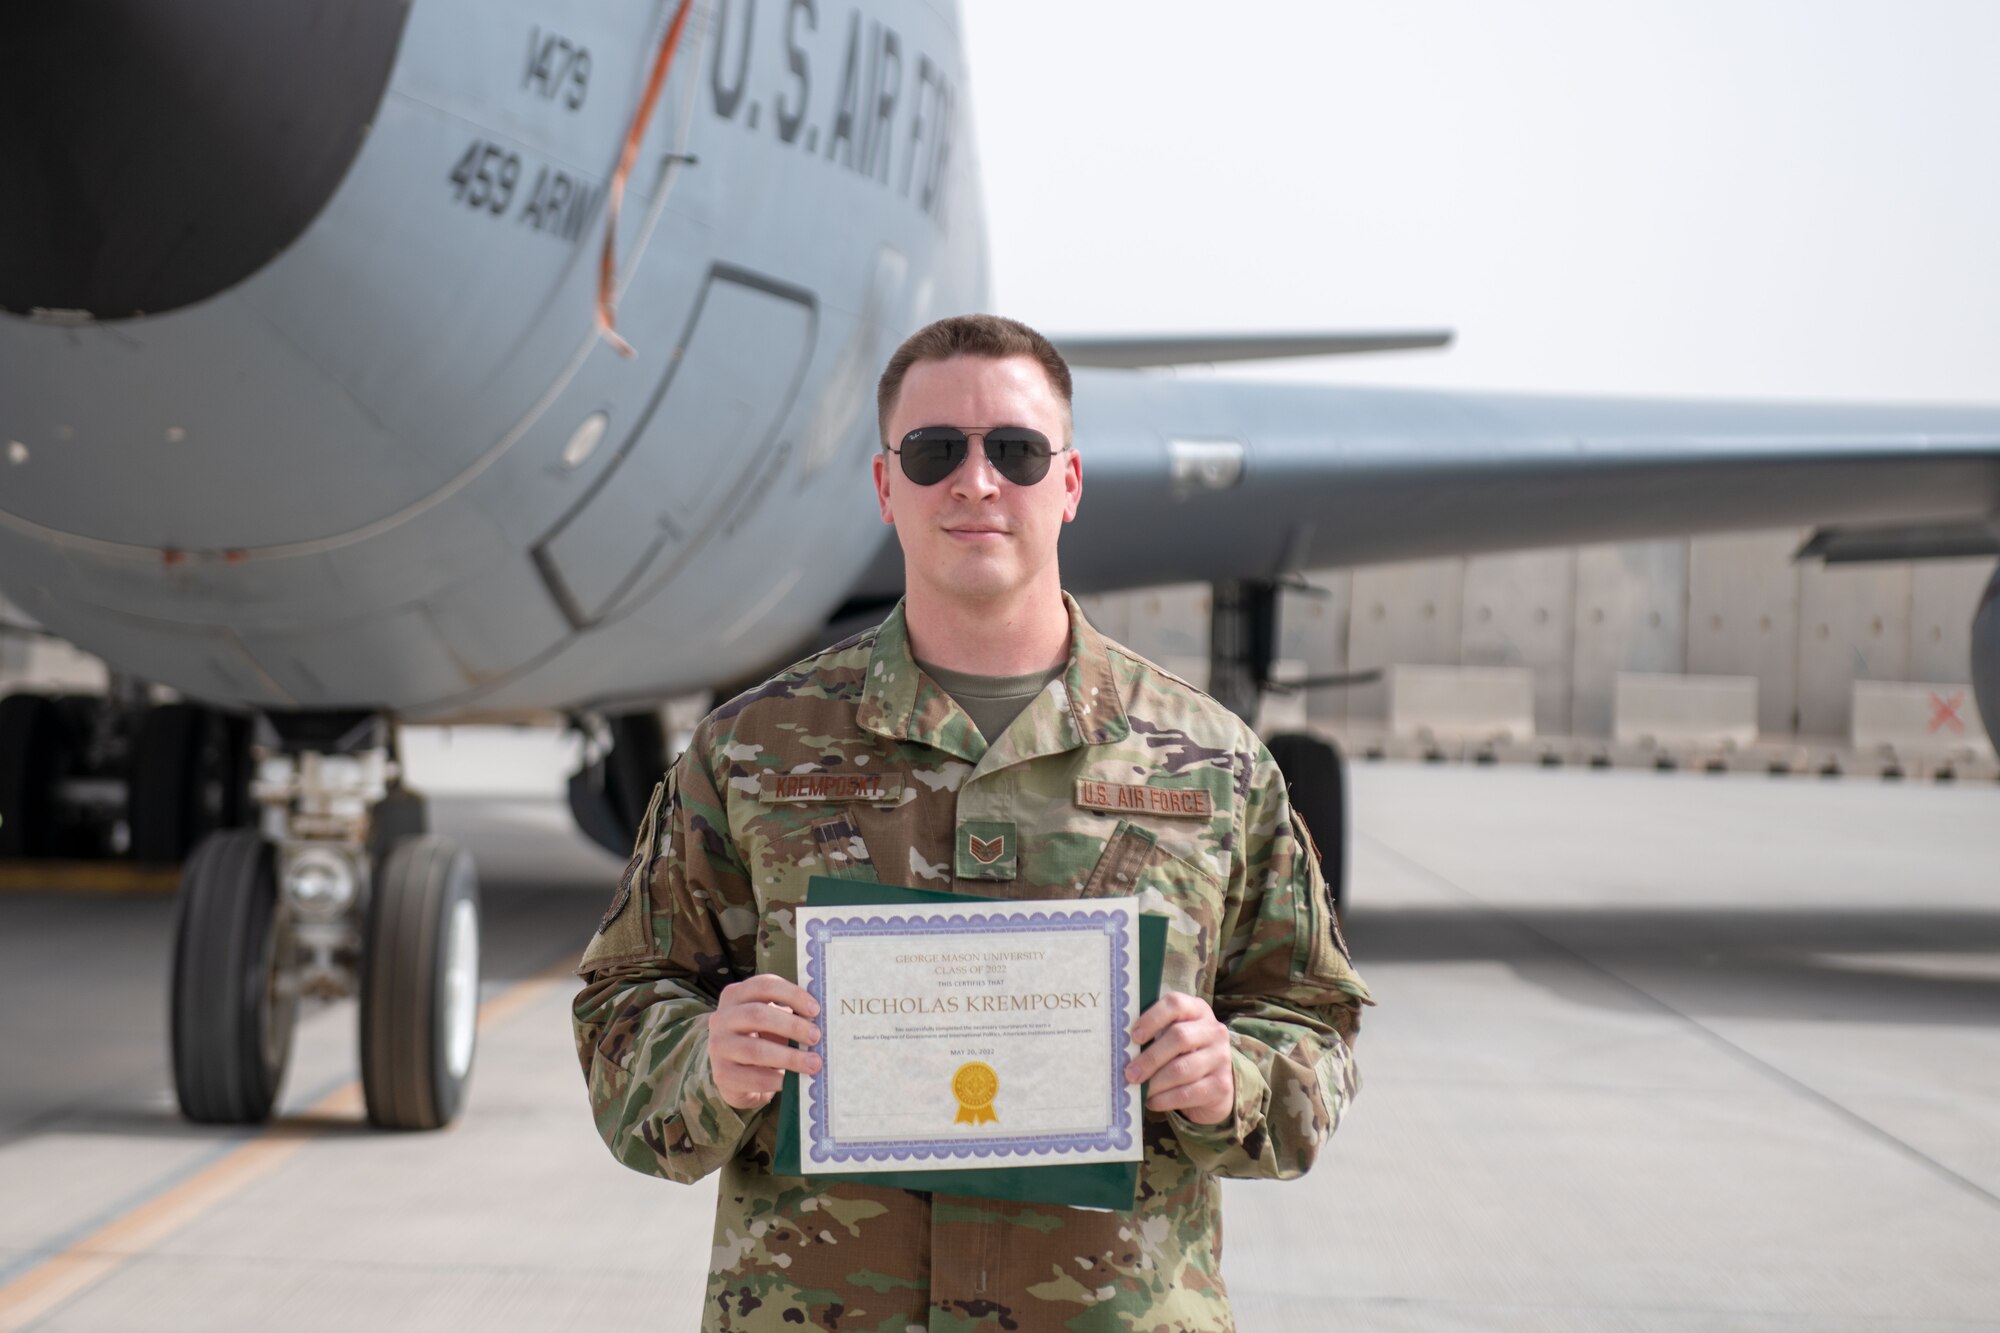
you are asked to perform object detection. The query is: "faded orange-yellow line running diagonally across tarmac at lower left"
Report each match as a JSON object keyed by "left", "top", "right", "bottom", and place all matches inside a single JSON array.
[{"left": 0, "top": 959, "right": 576, "bottom": 1333}]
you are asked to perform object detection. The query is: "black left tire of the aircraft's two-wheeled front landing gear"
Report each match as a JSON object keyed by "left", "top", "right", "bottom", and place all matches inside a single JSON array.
[{"left": 170, "top": 829, "right": 298, "bottom": 1125}]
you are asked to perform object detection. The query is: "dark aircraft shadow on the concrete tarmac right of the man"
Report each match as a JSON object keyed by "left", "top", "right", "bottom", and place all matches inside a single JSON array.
[{"left": 1346, "top": 907, "right": 2000, "bottom": 1025}]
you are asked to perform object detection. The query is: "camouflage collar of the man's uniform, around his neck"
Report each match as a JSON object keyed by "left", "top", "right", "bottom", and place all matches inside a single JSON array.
[{"left": 854, "top": 592, "right": 1132, "bottom": 769}]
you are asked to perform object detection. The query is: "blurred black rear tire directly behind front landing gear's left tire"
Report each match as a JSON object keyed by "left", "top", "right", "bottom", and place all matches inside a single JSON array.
[{"left": 126, "top": 703, "right": 250, "bottom": 865}]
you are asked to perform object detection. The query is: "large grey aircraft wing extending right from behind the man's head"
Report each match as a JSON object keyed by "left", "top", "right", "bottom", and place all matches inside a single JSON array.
[{"left": 1032, "top": 370, "right": 2000, "bottom": 590}]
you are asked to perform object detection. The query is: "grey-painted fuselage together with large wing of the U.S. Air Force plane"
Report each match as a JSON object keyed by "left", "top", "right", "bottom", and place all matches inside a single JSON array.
[{"left": 0, "top": 0, "right": 2000, "bottom": 719}]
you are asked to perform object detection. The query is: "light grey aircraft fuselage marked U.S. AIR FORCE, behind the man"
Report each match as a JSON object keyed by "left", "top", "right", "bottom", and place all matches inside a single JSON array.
[{"left": 0, "top": 0, "right": 986, "bottom": 717}]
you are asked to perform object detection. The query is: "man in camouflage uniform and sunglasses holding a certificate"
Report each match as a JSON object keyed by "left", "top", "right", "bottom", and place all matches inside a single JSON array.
[{"left": 576, "top": 316, "right": 1368, "bottom": 1333}]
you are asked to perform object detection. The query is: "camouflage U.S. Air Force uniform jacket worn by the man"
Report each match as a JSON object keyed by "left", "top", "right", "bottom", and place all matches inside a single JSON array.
[{"left": 576, "top": 598, "right": 1368, "bottom": 1333}]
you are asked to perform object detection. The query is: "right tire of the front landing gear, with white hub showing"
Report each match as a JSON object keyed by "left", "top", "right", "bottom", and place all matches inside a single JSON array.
[{"left": 362, "top": 833, "right": 480, "bottom": 1129}]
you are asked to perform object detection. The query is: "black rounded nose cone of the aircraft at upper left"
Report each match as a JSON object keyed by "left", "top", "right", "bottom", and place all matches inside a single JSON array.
[{"left": 0, "top": 0, "right": 408, "bottom": 318}]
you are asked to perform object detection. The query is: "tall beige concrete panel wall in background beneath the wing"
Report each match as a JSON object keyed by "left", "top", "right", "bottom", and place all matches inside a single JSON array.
[{"left": 1088, "top": 528, "right": 1994, "bottom": 745}]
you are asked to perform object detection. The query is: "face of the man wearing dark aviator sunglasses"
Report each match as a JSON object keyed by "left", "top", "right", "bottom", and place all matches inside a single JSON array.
[{"left": 874, "top": 356, "right": 1084, "bottom": 600}]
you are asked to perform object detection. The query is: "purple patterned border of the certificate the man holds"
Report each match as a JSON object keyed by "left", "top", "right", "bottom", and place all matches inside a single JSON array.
[{"left": 806, "top": 909, "right": 1132, "bottom": 1165}]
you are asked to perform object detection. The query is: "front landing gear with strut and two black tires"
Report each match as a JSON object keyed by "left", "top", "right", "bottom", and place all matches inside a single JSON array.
[{"left": 172, "top": 713, "right": 480, "bottom": 1129}]
